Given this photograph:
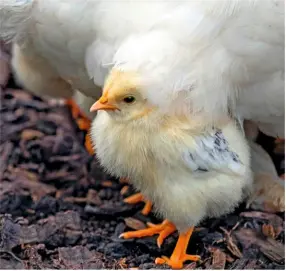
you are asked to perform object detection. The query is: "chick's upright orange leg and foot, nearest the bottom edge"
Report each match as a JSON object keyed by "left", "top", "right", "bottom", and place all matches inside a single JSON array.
[{"left": 155, "top": 227, "right": 200, "bottom": 269}]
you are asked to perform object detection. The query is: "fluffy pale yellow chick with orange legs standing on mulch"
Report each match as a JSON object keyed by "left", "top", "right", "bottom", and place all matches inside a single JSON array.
[{"left": 91, "top": 72, "right": 252, "bottom": 268}]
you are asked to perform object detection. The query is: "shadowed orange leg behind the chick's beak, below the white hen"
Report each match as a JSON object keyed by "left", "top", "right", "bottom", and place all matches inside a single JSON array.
[{"left": 66, "top": 99, "right": 94, "bottom": 155}]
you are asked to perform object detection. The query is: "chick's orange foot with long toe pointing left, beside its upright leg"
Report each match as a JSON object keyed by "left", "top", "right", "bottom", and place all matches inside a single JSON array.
[{"left": 120, "top": 220, "right": 176, "bottom": 250}]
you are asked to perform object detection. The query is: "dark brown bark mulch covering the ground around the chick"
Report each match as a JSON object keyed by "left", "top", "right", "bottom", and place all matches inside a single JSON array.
[{"left": 0, "top": 43, "right": 285, "bottom": 270}]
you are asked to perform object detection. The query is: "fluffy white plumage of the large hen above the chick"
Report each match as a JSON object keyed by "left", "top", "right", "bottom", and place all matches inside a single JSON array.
[{"left": 0, "top": 0, "right": 285, "bottom": 136}]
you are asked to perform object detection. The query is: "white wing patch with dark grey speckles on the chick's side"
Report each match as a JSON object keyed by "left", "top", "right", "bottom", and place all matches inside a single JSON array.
[{"left": 183, "top": 129, "right": 242, "bottom": 174}]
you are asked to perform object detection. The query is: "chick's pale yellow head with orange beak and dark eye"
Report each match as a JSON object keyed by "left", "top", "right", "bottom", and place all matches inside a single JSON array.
[{"left": 90, "top": 71, "right": 156, "bottom": 121}]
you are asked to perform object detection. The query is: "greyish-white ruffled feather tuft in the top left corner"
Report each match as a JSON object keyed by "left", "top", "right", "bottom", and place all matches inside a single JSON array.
[{"left": 0, "top": 0, "right": 34, "bottom": 41}]
